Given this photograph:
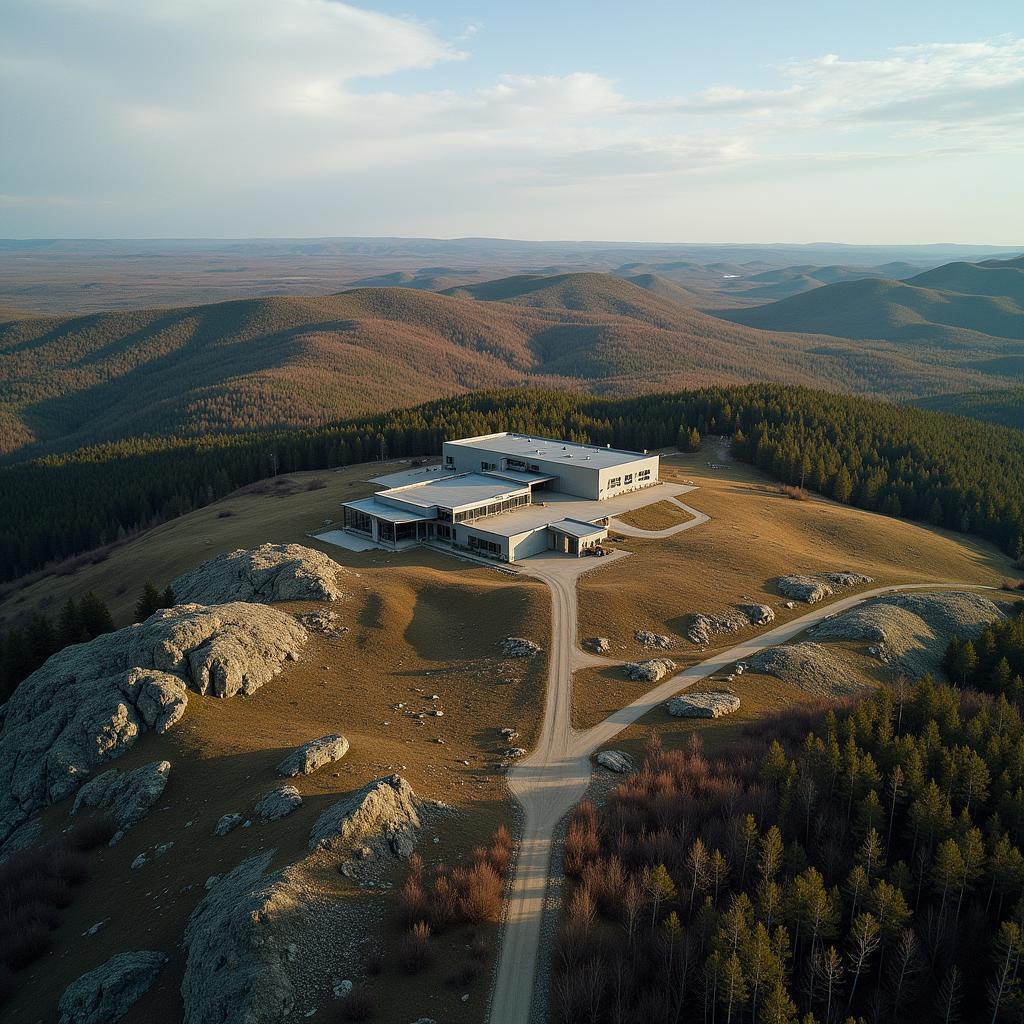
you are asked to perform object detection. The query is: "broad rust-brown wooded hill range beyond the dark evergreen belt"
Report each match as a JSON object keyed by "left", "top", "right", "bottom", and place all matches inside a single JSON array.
[{"left": 0, "top": 273, "right": 1014, "bottom": 458}]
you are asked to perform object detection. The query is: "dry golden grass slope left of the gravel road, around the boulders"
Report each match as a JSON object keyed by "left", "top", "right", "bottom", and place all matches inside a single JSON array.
[{"left": 5, "top": 471, "right": 550, "bottom": 1024}]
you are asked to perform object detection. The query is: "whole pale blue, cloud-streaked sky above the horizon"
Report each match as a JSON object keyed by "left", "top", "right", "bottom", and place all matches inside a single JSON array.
[{"left": 0, "top": 0, "right": 1024, "bottom": 246}]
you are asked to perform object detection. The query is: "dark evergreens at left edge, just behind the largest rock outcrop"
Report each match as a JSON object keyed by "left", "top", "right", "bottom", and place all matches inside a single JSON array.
[{"left": 0, "top": 581, "right": 174, "bottom": 702}]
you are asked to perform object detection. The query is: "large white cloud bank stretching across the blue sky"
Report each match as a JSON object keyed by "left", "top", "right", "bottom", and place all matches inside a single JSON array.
[{"left": 0, "top": 0, "right": 1024, "bottom": 234}]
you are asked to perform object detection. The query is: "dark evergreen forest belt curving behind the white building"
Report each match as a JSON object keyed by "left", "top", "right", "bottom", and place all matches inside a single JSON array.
[{"left": 0, "top": 384, "right": 1024, "bottom": 580}]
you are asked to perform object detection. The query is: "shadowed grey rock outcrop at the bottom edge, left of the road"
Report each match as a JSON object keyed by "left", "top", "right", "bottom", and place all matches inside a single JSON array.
[{"left": 181, "top": 850, "right": 309, "bottom": 1024}]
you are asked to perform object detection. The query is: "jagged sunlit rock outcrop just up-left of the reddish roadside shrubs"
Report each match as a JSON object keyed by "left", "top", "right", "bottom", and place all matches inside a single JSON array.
[{"left": 309, "top": 775, "right": 422, "bottom": 857}]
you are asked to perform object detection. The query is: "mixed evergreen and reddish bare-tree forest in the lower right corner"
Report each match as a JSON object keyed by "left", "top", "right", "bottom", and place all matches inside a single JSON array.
[{"left": 554, "top": 677, "right": 1024, "bottom": 1024}]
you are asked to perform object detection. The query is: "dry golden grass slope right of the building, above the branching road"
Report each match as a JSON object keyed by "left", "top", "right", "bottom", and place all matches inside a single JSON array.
[{"left": 572, "top": 452, "right": 1008, "bottom": 731}]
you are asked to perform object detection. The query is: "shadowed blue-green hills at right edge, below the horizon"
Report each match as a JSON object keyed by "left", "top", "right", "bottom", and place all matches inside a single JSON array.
[{"left": 720, "top": 259, "right": 1024, "bottom": 352}]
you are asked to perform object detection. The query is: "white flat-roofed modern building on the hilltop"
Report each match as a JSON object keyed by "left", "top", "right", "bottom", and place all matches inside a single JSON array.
[{"left": 343, "top": 433, "right": 658, "bottom": 562}]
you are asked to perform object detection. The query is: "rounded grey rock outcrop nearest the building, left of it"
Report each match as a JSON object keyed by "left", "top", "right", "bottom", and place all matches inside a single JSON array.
[{"left": 171, "top": 544, "right": 347, "bottom": 604}]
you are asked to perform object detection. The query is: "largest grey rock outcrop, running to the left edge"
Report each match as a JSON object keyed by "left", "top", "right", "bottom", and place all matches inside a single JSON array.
[{"left": 0, "top": 603, "right": 307, "bottom": 841}]
